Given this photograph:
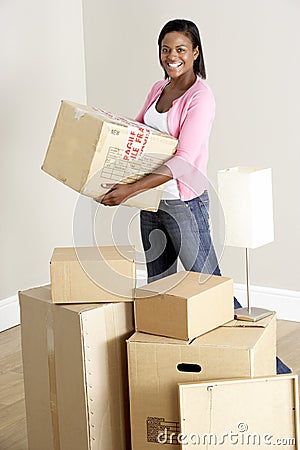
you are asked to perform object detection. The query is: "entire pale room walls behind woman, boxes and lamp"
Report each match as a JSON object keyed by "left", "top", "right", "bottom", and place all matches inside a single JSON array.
[{"left": 0, "top": 0, "right": 300, "bottom": 324}]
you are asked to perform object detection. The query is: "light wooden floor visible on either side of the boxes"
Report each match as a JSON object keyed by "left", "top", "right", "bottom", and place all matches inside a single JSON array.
[{"left": 0, "top": 320, "right": 300, "bottom": 450}]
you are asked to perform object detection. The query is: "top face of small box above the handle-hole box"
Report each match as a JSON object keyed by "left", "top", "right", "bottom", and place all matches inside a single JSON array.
[{"left": 136, "top": 271, "right": 232, "bottom": 298}]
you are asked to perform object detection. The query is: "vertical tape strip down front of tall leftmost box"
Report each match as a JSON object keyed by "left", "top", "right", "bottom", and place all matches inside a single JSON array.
[{"left": 46, "top": 305, "right": 60, "bottom": 450}]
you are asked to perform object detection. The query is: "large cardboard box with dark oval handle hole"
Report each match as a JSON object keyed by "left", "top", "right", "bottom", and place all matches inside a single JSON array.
[{"left": 127, "top": 314, "right": 276, "bottom": 450}]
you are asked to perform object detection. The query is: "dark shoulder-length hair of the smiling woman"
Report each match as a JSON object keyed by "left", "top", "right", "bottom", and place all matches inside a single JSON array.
[{"left": 158, "top": 19, "right": 206, "bottom": 80}]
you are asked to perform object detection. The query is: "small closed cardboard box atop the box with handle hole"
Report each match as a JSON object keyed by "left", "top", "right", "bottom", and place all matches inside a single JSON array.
[{"left": 135, "top": 271, "right": 234, "bottom": 340}]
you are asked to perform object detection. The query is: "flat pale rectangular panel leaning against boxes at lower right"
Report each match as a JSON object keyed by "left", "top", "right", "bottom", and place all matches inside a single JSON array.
[{"left": 178, "top": 375, "right": 299, "bottom": 450}]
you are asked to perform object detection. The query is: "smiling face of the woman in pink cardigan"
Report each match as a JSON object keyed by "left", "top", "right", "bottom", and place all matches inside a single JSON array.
[{"left": 160, "top": 31, "right": 199, "bottom": 78}]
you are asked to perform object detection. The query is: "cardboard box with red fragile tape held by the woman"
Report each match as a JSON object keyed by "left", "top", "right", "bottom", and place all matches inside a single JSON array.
[{"left": 42, "top": 100, "right": 177, "bottom": 211}]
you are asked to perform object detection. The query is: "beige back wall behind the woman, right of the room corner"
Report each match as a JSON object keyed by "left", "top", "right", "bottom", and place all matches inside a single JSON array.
[{"left": 83, "top": 0, "right": 300, "bottom": 290}]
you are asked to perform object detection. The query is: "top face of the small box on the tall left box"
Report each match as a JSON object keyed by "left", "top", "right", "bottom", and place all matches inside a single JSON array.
[{"left": 51, "top": 245, "right": 135, "bottom": 262}]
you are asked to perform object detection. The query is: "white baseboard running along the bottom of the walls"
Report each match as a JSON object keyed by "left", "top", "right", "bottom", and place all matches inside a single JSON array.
[{"left": 0, "top": 276, "right": 300, "bottom": 332}]
